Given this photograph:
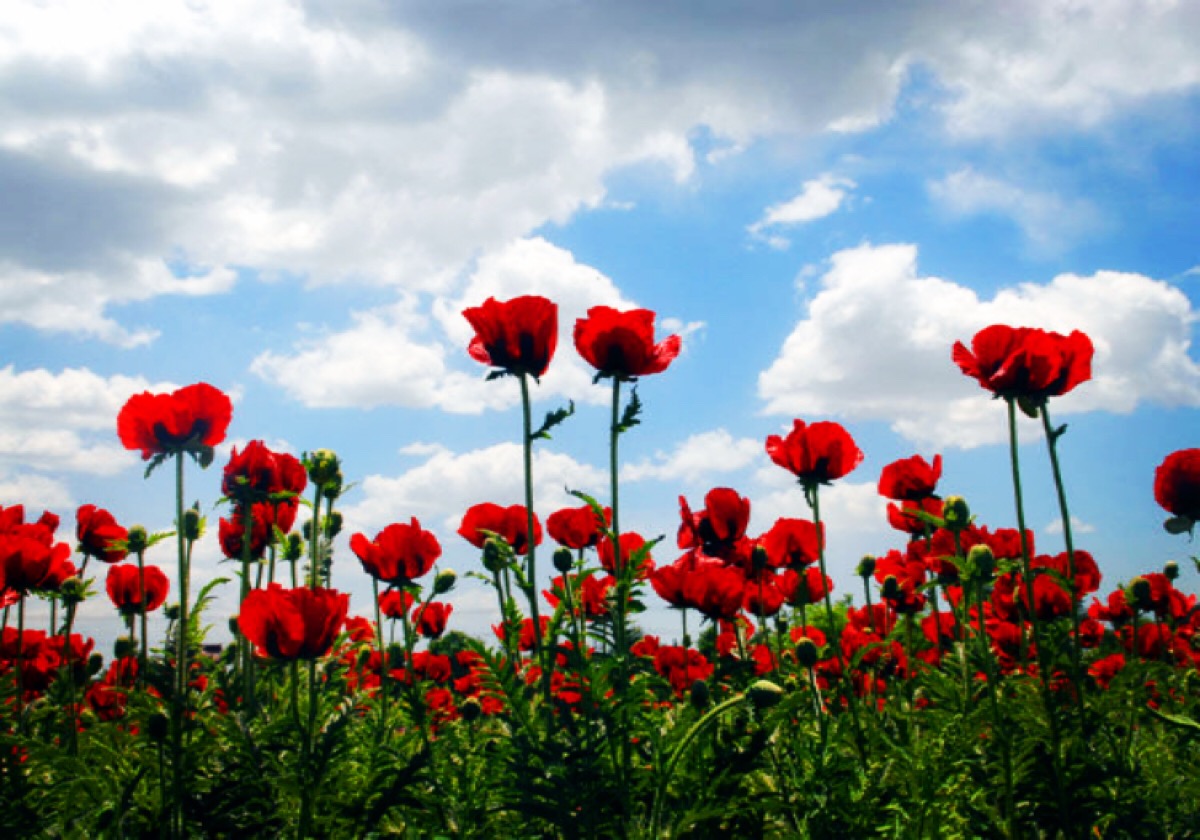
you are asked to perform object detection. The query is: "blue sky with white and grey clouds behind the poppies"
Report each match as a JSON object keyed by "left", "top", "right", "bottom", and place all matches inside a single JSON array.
[{"left": 0, "top": 0, "right": 1200, "bottom": 648}]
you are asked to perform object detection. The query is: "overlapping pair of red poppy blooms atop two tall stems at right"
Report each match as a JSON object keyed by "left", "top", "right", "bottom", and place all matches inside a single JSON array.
[{"left": 952, "top": 324, "right": 1093, "bottom": 400}]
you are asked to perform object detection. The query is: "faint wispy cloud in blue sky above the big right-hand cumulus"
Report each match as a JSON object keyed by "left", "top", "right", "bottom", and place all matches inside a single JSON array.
[{"left": 929, "top": 167, "right": 1104, "bottom": 252}]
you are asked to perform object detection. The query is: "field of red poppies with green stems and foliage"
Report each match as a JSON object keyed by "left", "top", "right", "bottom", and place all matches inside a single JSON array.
[{"left": 0, "top": 295, "right": 1200, "bottom": 839}]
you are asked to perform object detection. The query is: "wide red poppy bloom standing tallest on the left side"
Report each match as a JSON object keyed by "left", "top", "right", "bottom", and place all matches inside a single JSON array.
[{"left": 116, "top": 382, "right": 233, "bottom": 461}]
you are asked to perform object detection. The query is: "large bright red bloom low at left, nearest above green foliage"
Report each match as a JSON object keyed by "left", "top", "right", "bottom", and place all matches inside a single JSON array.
[{"left": 238, "top": 583, "right": 350, "bottom": 661}]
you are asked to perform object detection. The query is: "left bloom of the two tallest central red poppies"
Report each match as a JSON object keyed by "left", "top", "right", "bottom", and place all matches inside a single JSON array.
[{"left": 462, "top": 295, "right": 558, "bottom": 379}]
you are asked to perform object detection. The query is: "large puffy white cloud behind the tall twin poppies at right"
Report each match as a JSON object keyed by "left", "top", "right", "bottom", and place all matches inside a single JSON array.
[{"left": 758, "top": 245, "right": 1200, "bottom": 448}]
